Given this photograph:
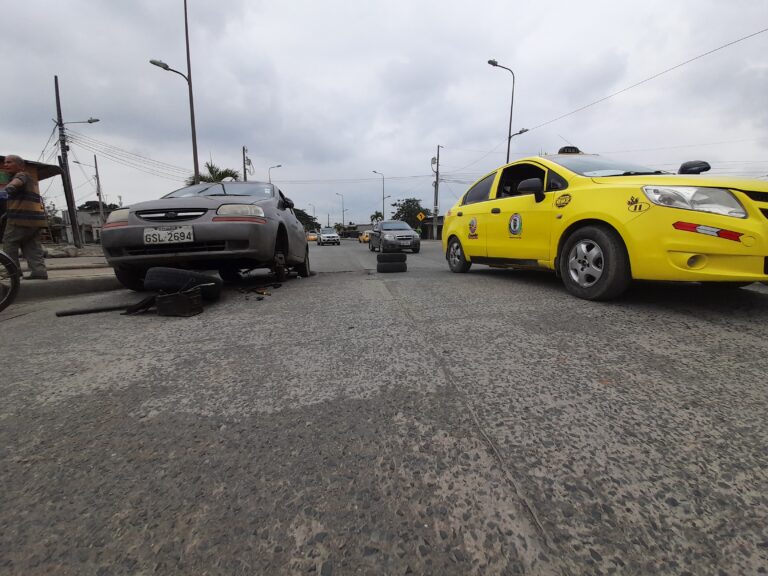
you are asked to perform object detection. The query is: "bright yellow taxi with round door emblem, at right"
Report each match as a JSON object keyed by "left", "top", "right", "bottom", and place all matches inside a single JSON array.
[{"left": 443, "top": 146, "right": 768, "bottom": 300}]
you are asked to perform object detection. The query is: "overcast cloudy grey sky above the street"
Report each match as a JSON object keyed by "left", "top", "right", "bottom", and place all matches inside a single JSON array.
[{"left": 0, "top": 0, "right": 768, "bottom": 224}]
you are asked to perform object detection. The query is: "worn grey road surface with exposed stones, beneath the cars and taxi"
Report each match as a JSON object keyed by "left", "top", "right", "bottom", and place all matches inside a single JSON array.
[{"left": 0, "top": 241, "right": 768, "bottom": 576}]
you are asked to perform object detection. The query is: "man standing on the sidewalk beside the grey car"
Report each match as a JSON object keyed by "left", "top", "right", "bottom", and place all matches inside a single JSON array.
[{"left": 3, "top": 154, "right": 48, "bottom": 280}]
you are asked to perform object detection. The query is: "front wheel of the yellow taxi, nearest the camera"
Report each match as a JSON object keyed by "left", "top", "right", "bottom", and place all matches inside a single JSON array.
[{"left": 558, "top": 226, "right": 631, "bottom": 300}]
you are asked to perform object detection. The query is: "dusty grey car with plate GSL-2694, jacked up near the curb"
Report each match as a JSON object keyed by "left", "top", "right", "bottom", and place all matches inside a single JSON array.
[{"left": 102, "top": 182, "right": 310, "bottom": 290}]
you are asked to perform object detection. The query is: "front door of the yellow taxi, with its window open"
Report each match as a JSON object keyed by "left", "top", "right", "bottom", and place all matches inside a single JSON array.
[{"left": 486, "top": 162, "right": 554, "bottom": 265}]
